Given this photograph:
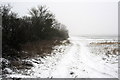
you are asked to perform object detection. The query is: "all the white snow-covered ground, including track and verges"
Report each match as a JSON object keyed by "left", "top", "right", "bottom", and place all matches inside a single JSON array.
[{"left": 3, "top": 37, "right": 118, "bottom": 78}]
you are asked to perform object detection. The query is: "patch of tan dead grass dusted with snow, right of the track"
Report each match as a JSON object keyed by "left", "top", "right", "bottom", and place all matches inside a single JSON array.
[{"left": 89, "top": 42, "right": 120, "bottom": 56}]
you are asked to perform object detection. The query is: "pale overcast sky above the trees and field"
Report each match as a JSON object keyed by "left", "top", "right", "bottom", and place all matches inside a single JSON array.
[{"left": 1, "top": 0, "right": 118, "bottom": 35}]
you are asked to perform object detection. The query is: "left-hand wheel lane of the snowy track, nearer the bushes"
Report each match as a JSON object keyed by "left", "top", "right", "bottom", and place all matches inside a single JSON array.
[{"left": 52, "top": 44, "right": 78, "bottom": 78}]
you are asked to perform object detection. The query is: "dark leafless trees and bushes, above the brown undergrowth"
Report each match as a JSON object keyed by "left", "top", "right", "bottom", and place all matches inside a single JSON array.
[{"left": 0, "top": 5, "right": 68, "bottom": 57}]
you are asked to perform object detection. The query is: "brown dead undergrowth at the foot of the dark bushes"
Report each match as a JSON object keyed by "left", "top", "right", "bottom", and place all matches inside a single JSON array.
[{"left": 21, "top": 40, "right": 61, "bottom": 58}]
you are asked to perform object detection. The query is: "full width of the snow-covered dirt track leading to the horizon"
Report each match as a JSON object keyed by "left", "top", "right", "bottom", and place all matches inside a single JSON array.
[{"left": 52, "top": 40, "right": 117, "bottom": 78}]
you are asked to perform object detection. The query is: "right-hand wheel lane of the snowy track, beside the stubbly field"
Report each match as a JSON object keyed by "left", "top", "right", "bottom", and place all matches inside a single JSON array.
[{"left": 71, "top": 41, "right": 117, "bottom": 78}]
